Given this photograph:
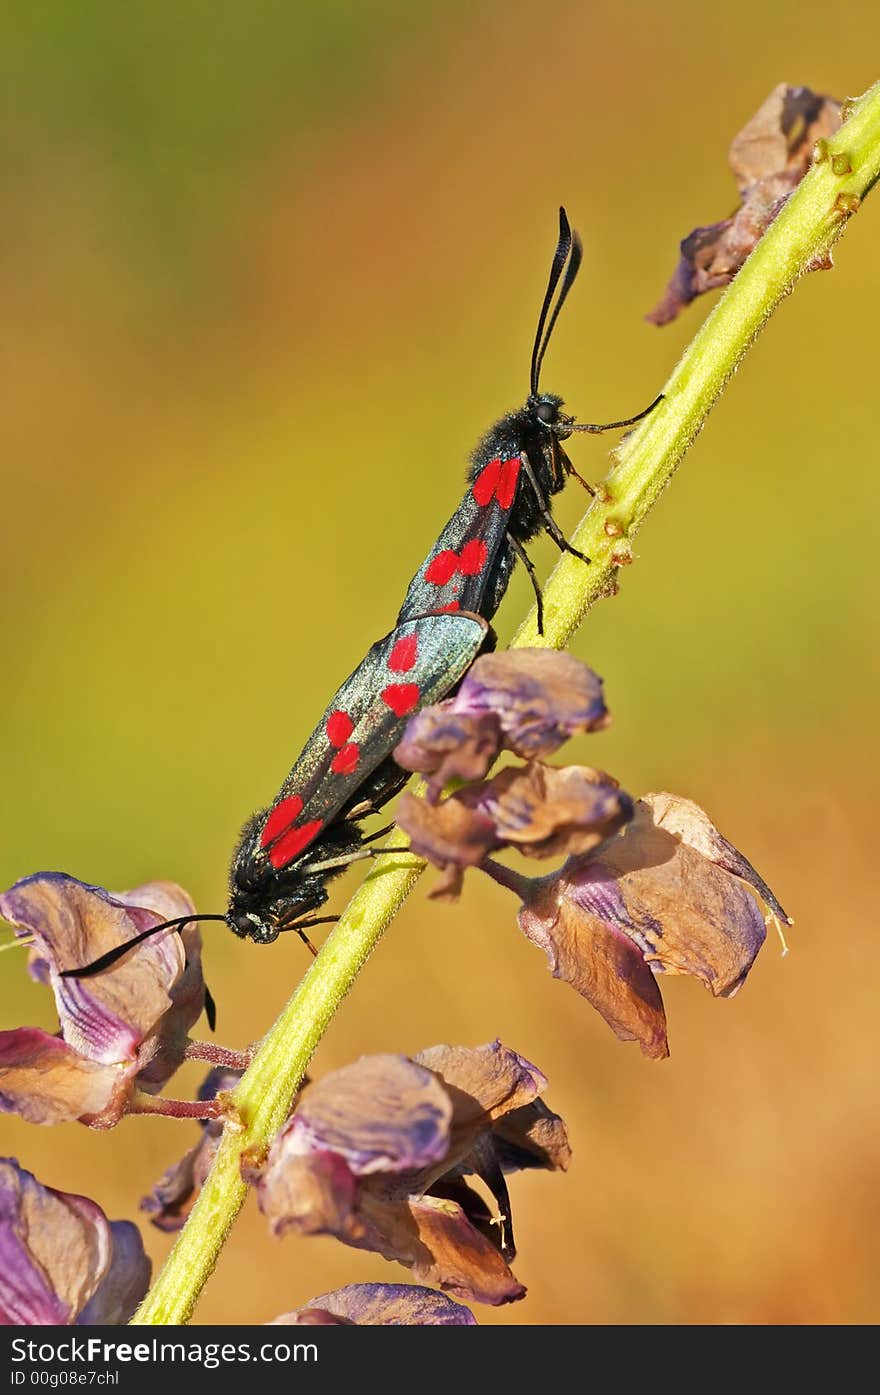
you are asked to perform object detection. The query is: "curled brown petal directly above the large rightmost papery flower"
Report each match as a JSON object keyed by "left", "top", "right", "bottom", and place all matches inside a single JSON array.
[{"left": 460, "top": 760, "right": 633, "bottom": 858}]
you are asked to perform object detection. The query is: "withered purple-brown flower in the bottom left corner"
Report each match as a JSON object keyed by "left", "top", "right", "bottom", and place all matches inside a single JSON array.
[{"left": 0, "top": 1158, "right": 151, "bottom": 1327}]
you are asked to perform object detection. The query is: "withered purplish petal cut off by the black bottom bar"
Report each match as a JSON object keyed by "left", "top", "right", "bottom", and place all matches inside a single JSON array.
[{"left": 268, "top": 1283, "right": 477, "bottom": 1327}]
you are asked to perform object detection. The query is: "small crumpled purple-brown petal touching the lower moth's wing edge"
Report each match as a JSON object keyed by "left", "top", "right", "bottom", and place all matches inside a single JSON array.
[{"left": 395, "top": 702, "right": 501, "bottom": 804}]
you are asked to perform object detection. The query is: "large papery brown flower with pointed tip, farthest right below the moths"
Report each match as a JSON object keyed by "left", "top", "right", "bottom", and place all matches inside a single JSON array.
[{"left": 510, "top": 794, "right": 788, "bottom": 1057}]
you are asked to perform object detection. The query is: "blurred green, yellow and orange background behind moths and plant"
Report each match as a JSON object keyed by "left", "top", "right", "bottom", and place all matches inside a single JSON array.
[{"left": 0, "top": 0, "right": 880, "bottom": 1322}]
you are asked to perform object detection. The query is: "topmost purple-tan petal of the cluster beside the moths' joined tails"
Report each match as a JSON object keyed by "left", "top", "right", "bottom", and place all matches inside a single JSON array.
[{"left": 450, "top": 649, "right": 611, "bottom": 769}]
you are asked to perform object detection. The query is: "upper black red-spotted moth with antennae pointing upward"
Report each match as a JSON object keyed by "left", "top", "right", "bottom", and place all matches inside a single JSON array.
[{"left": 397, "top": 208, "right": 661, "bottom": 633}]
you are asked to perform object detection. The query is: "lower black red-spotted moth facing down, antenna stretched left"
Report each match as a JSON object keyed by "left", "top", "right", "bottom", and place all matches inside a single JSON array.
[{"left": 64, "top": 612, "right": 492, "bottom": 978}]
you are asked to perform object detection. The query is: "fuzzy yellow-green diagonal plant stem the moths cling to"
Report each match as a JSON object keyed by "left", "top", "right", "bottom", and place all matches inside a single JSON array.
[{"left": 132, "top": 84, "right": 880, "bottom": 1324}]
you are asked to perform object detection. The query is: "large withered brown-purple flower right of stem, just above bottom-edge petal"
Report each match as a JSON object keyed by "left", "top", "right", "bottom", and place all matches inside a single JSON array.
[{"left": 254, "top": 1042, "right": 569, "bottom": 1304}]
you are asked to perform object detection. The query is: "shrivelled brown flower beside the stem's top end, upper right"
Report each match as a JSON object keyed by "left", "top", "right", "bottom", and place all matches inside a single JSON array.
[{"left": 646, "top": 82, "right": 841, "bottom": 325}]
